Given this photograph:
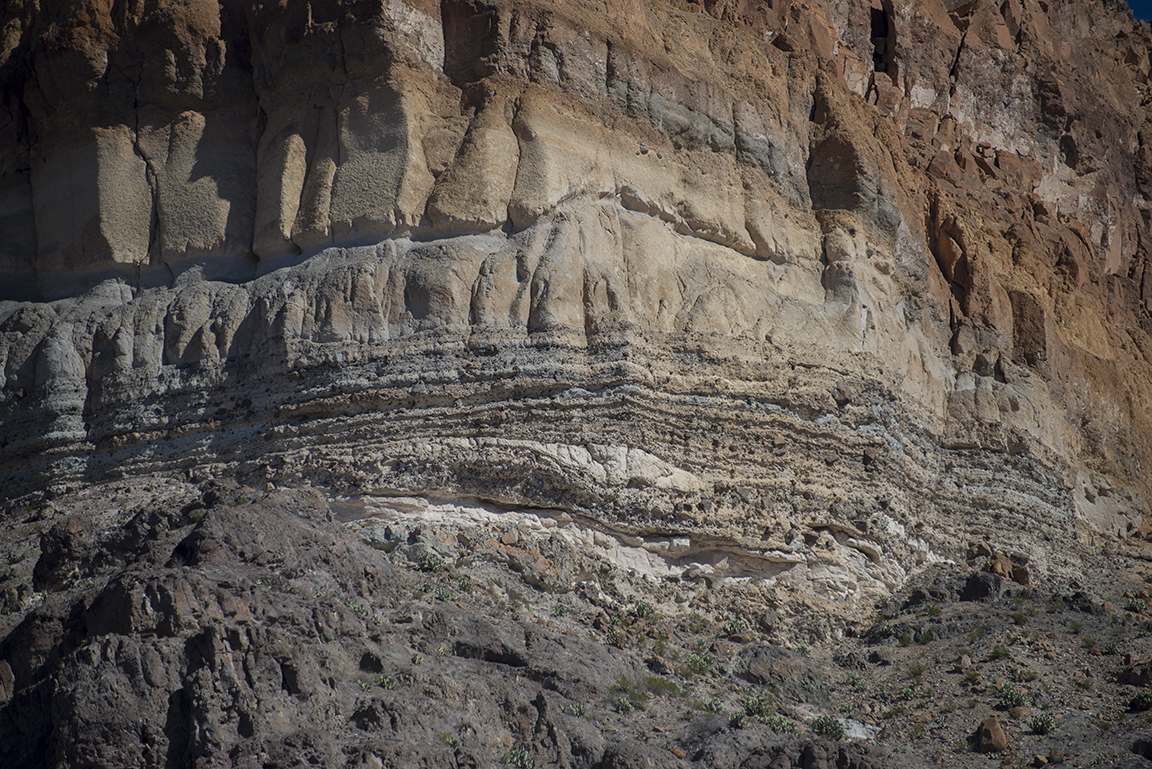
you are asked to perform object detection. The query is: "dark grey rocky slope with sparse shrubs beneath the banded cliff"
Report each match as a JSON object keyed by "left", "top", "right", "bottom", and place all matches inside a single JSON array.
[{"left": 9, "top": 477, "right": 1152, "bottom": 769}]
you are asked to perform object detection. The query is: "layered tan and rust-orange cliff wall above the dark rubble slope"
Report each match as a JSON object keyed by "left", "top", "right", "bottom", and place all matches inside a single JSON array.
[{"left": 0, "top": 0, "right": 1152, "bottom": 617}]
